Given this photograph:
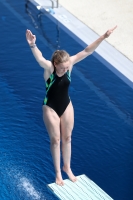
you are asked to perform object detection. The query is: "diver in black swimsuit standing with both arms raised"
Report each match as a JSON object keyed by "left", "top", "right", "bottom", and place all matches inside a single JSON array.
[{"left": 26, "top": 26, "right": 117, "bottom": 186}]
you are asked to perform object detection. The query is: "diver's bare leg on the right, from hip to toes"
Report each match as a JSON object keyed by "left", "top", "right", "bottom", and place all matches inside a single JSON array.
[{"left": 61, "top": 102, "right": 77, "bottom": 182}]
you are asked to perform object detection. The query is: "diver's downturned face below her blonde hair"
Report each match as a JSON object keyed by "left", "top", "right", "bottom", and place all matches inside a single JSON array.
[{"left": 54, "top": 60, "right": 70, "bottom": 75}]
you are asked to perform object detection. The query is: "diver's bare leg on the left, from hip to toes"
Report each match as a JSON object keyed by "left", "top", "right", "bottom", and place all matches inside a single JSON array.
[{"left": 43, "top": 106, "right": 64, "bottom": 185}]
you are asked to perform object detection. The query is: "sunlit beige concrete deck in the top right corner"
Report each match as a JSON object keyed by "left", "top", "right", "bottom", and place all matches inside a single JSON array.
[{"left": 59, "top": 0, "right": 133, "bottom": 62}]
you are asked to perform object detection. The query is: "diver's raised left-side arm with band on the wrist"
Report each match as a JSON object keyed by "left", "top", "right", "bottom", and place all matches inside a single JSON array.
[{"left": 26, "top": 29, "right": 52, "bottom": 69}]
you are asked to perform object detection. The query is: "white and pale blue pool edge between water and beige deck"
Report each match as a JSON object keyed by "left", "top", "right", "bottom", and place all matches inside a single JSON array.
[{"left": 28, "top": 0, "right": 133, "bottom": 89}]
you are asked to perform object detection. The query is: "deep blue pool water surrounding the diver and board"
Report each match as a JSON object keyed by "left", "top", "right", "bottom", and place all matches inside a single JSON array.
[{"left": 0, "top": 0, "right": 133, "bottom": 200}]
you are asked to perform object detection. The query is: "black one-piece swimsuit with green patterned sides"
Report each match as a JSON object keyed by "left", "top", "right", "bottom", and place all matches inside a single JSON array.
[{"left": 43, "top": 70, "right": 71, "bottom": 117}]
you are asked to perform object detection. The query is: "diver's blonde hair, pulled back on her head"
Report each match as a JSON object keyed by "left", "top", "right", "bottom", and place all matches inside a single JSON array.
[{"left": 51, "top": 50, "right": 70, "bottom": 65}]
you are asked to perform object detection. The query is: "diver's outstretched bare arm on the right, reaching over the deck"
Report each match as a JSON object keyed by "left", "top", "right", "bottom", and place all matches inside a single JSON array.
[{"left": 70, "top": 26, "right": 117, "bottom": 65}]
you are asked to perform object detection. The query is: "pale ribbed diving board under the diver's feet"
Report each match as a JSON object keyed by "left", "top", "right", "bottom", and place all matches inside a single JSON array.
[{"left": 47, "top": 174, "right": 113, "bottom": 200}]
